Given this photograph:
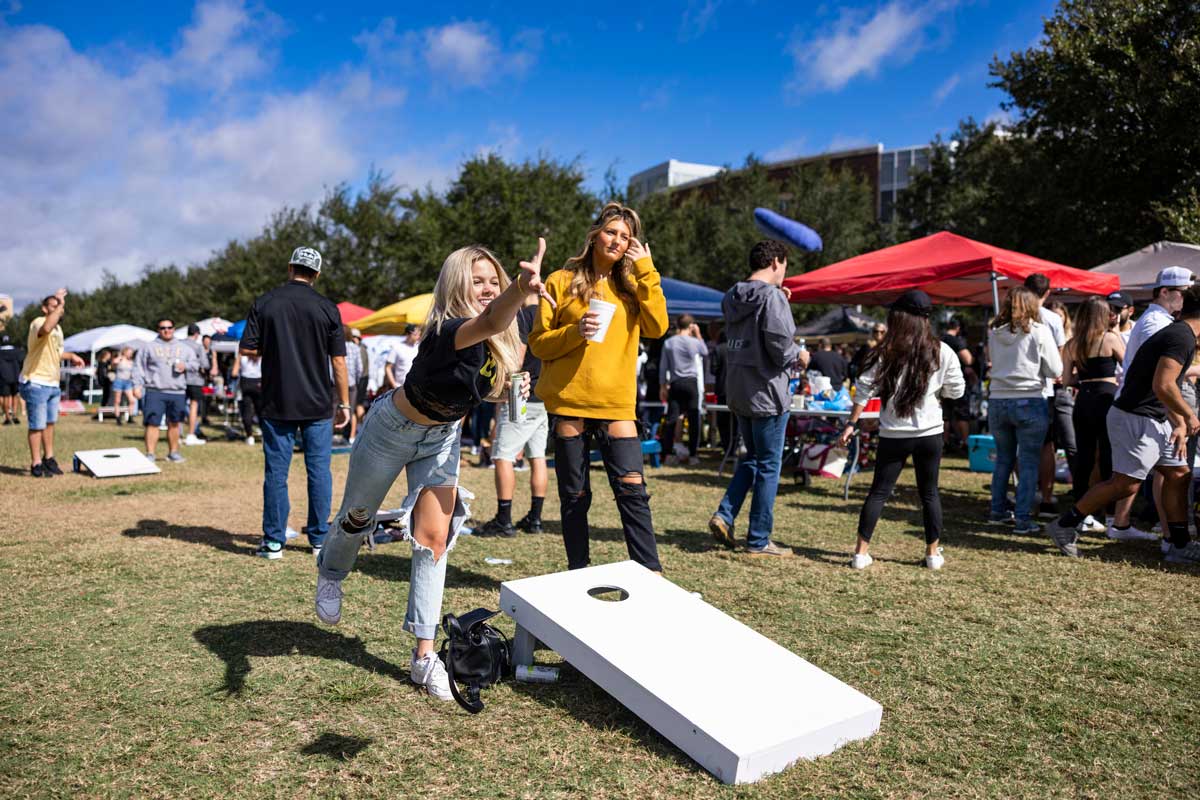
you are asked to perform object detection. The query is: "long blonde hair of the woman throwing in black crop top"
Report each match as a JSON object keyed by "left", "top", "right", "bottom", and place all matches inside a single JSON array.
[{"left": 421, "top": 245, "right": 521, "bottom": 401}]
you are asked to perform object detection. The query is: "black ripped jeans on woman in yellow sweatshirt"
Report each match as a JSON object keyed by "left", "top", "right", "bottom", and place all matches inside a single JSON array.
[{"left": 553, "top": 417, "right": 662, "bottom": 572}]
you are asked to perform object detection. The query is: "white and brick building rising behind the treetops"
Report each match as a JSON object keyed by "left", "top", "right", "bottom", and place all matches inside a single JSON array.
[{"left": 628, "top": 144, "right": 929, "bottom": 223}]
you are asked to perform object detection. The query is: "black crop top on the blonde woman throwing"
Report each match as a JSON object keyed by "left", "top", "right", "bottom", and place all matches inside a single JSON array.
[{"left": 404, "top": 318, "right": 498, "bottom": 422}]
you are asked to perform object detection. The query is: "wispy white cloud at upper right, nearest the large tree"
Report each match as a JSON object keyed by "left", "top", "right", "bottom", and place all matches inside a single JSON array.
[{"left": 788, "top": 0, "right": 958, "bottom": 91}]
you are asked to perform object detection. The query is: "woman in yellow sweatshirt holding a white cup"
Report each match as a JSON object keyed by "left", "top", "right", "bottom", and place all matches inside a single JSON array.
[{"left": 529, "top": 203, "right": 667, "bottom": 572}]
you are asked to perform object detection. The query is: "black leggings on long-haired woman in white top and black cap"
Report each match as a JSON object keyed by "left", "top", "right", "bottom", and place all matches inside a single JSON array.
[{"left": 858, "top": 433, "right": 942, "bottom": 545}]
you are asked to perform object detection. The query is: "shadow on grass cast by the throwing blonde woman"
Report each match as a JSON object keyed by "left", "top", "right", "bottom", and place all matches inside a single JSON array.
[{"left": 192, "top": 620, "right": 408, "bottom": 694}]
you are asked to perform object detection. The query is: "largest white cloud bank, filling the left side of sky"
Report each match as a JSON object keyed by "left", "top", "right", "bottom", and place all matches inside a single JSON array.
[{"left": 0, "top": 1, "right": 448, "bottom": 307}]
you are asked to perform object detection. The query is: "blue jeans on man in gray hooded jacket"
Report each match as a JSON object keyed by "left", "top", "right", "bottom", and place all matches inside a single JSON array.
[{"left": 716, "top": 411, "right": 791, "bottom": 551}]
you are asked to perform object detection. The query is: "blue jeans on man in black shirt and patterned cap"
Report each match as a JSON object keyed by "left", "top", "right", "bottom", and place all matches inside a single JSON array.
[{"left": 259, "top": 419, "right": 334, "bottom": 547}]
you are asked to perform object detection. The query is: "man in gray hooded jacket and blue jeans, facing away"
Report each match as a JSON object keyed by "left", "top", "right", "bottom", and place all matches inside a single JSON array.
[{"left": 708, "top": 240, "right": 809, "bottom": 557}]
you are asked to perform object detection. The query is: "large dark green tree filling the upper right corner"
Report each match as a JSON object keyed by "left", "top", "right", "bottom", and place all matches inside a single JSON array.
[{"left": 900, "top": 0, "right": 1200, "bottom": 266}]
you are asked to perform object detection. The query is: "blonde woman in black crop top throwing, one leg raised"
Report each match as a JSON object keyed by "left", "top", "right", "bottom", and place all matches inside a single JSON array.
[{"left": 317, "top": 239, "right": 546, "bottom": 700}]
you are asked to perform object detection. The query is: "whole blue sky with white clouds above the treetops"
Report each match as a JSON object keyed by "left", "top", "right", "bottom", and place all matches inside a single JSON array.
[{"left": 0, "top": 0, "right": 1054, "bottom": 302}]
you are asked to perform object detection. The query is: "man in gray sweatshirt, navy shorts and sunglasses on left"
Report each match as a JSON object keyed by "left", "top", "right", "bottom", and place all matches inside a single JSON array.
[{"left": 133, "top": 319, "right": 200, "bottom": 463}]
